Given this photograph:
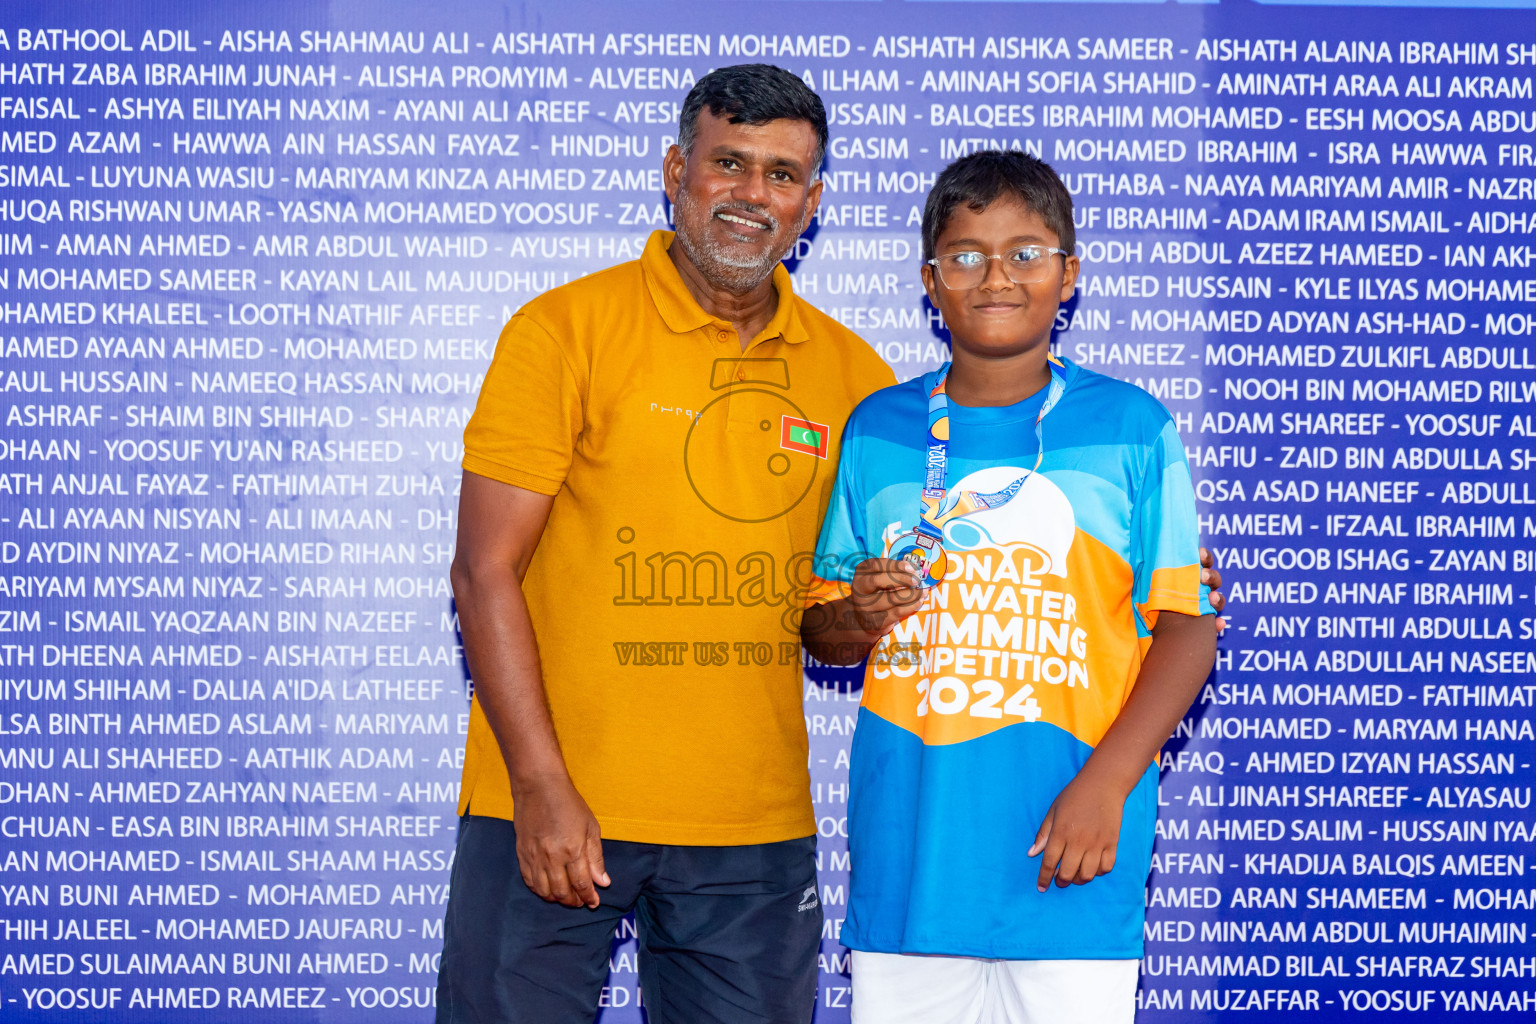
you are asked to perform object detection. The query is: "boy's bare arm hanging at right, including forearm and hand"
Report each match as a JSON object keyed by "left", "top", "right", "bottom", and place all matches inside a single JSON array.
[{"left": 1029, "top": 611, "right": 1217, "bottom": 892}]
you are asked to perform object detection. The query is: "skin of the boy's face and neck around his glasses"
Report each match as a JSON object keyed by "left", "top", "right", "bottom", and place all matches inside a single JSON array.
[{"left": 923, "top": 198, "right": 1078, "bottom": 404}]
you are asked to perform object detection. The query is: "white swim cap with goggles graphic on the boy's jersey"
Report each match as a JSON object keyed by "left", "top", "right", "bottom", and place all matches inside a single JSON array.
[{"left": 943, "top": 465, "right": 1077, "bottom": 576}]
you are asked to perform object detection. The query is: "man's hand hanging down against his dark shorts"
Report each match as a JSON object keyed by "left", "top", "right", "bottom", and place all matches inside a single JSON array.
[{"left": 511, "top": 778, "right": 610, "bottom": 907}]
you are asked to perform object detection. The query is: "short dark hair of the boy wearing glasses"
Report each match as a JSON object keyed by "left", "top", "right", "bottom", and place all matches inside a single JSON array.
[{"left": 923, "top": 149, "right": 1077, "bottom": 259}]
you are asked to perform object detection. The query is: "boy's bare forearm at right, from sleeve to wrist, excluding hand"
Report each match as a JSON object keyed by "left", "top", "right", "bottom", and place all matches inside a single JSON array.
[{"left": 1081, "top": 611, "right": 1217, "bottom": 797}]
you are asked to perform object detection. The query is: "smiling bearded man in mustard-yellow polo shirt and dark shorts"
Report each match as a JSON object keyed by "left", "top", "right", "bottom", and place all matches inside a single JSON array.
[{"left": 438, "top": 64, "right": 894, "bottom": 1024}]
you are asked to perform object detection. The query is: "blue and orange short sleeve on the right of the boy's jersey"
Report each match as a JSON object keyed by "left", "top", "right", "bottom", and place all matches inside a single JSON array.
[{"left": 1130, "top": 419, "right": 1213, "bottom": 628}]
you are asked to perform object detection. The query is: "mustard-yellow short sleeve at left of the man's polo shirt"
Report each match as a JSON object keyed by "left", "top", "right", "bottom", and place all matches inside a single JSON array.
[{"left": 464, "top": 313, "right": 585, "bottom": 494}]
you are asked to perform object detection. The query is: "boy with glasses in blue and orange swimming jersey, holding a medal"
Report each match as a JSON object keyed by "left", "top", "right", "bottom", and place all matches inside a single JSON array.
[{"left": 802, "top": 152, "right": 1217, "bottom": 1024}]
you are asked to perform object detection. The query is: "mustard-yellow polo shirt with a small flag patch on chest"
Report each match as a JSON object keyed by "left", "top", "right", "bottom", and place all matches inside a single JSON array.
[{"left": 459, "top": 232, "right": 894, "bottom": 846}]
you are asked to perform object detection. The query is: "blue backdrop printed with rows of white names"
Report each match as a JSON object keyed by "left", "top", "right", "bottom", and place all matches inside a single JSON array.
[{"left": 0, "top": 0, "right": 1536, "bottom": 1024}]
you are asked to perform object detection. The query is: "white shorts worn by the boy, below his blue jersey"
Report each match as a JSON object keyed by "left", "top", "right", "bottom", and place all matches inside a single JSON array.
[{"left": 852, "top": 950, "right": 1141, "bottom": 1024}]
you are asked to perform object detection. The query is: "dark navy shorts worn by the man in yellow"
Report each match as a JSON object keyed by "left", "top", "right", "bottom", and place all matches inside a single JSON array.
[{"left": 438, "top": 817, "right": 822, "bottom": 1024}]
